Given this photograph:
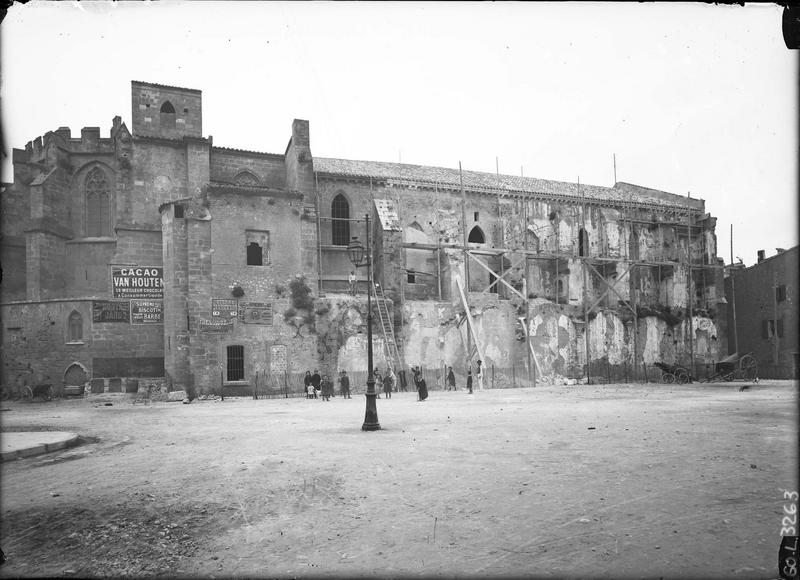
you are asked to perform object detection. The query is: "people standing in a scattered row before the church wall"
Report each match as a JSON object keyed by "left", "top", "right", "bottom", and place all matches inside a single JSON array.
[{"left": 303, "top": 360, "right": 483, "bottom": 401}]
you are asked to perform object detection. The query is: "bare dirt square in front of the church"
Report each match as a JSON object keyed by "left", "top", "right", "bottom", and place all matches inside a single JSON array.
[{"left": 0, "top": 381, "right": 798, "bottom": 579}]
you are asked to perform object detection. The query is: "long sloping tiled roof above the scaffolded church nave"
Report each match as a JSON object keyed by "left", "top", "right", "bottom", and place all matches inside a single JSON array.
[{"left": 314, "top": 157, "right": 700, "bottom": 207}]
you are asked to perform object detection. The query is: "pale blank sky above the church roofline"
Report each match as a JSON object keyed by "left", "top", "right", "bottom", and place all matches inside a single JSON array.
[{"left": 0, "top": 0, "right": 798, "bottom": 265}]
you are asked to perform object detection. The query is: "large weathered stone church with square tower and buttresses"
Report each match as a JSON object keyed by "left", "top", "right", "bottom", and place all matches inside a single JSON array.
[{"left": 0, "top": 81, "right": 727, "bottom": 393}]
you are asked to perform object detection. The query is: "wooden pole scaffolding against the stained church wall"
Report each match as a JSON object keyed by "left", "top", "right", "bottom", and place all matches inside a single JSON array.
[{"left": 317, "top": 169, "right": 724, "bottom": 385}]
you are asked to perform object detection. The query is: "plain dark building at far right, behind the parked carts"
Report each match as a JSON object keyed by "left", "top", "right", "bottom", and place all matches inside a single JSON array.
[{"left": 725, "top": 246, "right": 800, "bottom": 379}]
